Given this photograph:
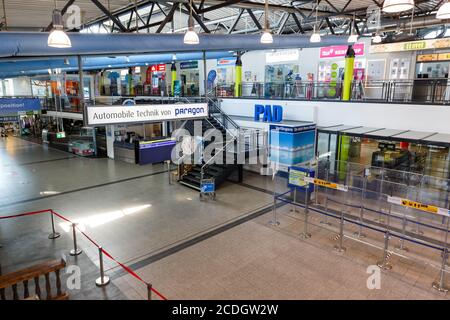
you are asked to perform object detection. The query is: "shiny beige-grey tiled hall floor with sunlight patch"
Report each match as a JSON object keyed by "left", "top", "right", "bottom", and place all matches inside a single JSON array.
[{"left": 0, "top": 138, "right": 446, "bottom": 299}]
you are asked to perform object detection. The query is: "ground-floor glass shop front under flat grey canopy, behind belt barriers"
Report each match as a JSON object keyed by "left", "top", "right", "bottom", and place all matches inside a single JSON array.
[{"left": 317, "top": 125, "right": 450, "bottom": 179}]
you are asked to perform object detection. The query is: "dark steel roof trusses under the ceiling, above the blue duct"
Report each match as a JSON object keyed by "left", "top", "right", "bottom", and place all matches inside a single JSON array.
[{"left": 0, "top": 0, "right": 444, "bottom": 38}]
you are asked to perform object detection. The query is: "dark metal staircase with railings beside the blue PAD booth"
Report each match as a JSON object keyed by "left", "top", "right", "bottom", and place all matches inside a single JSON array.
[{"left": 179, "top": 99, "right": 242, "bottom": 191}]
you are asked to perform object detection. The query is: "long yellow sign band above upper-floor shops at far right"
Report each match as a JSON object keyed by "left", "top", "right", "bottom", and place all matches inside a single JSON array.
[{"left": 370, "top": 38, "right": 450, "bottom": 53}]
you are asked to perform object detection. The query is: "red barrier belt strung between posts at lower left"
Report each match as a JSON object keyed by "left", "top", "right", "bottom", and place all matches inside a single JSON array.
[{"left": 0, "top": 209, "right": 167, "bottom": 300}]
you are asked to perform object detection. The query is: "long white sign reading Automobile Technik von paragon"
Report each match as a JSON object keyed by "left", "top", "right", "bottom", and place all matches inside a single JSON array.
[{"left": 87, "top": 103, "right": 208, "bottom": 126}]
